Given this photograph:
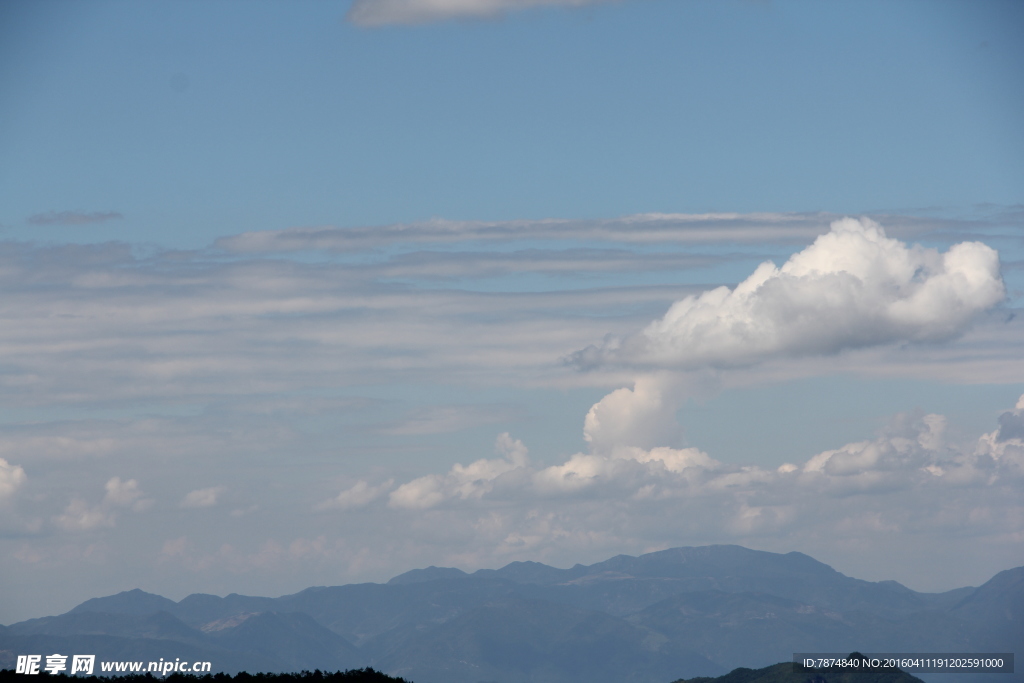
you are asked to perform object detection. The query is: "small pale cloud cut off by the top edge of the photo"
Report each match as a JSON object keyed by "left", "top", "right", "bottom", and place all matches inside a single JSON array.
[{"left": 347, "top": 0, "right": 608, "bottom": 26}]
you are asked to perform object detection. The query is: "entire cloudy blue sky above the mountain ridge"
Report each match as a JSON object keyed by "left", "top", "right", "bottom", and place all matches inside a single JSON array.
[{"left": 0, "top": 0, "right": 1024, "bottom": 624}]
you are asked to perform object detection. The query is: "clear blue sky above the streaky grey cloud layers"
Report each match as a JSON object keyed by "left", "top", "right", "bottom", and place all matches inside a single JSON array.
[{"left": 0, "top": 0, "right": 1024, "bottom": 248}]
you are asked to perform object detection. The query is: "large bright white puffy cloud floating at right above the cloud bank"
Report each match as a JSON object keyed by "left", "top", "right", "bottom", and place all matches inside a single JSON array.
[{"left": 573, "top": 218, "right": 1006, "bottom": 369}]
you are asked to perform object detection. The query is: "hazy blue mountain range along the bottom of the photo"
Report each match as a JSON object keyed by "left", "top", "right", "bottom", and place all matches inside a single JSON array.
[{"left": 0, "top": 546, "right": 1024, "bottom": 683}]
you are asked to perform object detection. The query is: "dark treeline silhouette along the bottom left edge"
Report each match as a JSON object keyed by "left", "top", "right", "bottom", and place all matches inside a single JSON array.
[{"left": 0, "top": 667, "right": 412, "bottom": 683}]
